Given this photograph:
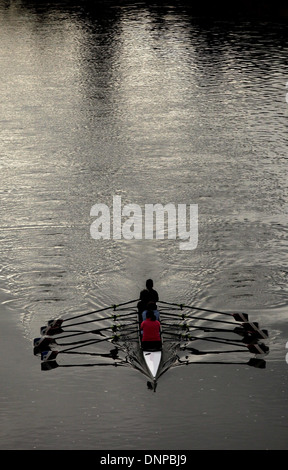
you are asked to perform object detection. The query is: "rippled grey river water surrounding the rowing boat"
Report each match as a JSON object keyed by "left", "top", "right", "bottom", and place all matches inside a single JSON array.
[{"left": 0, "top": 1, "right": 288, "bottom": 451}]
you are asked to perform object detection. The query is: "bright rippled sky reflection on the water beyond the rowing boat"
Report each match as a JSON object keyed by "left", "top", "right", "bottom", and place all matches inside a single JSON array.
[{"left": 0, "top": 1, "right": 288, "bottom": 452}]
